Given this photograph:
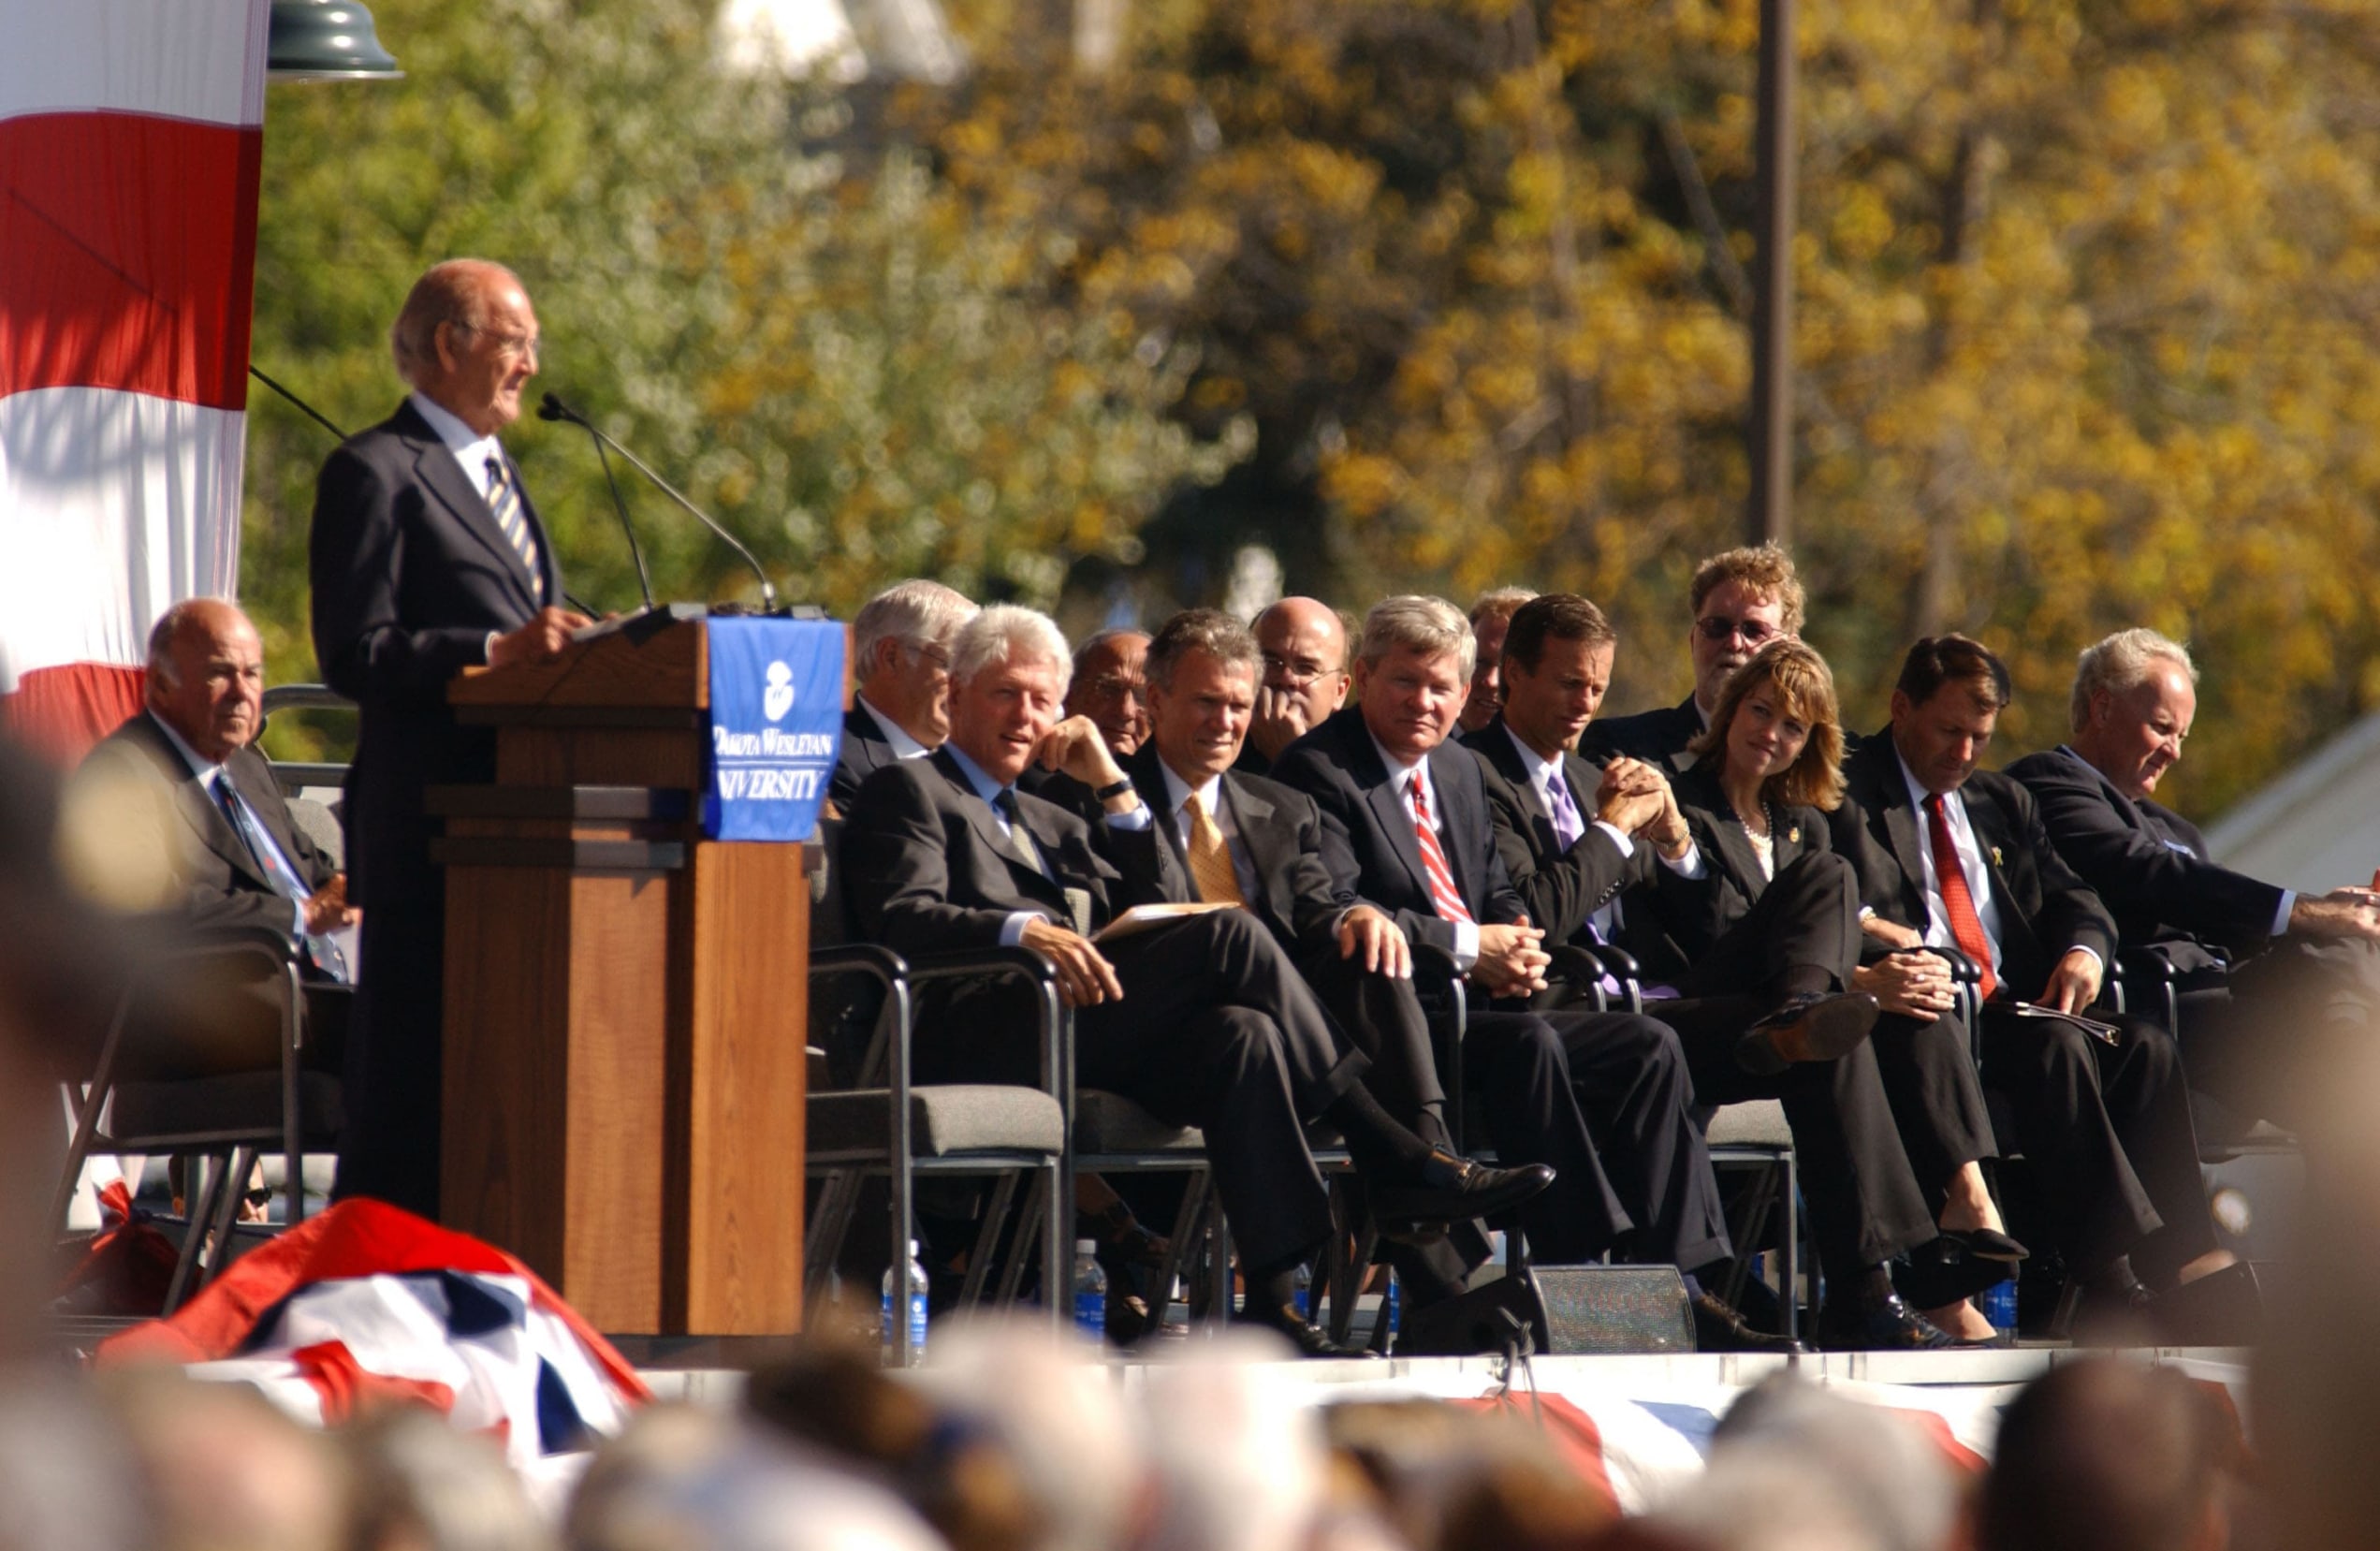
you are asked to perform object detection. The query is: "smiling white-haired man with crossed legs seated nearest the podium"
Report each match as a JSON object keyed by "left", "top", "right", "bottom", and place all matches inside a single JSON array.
[{"left": 845, "top": 605, "right": 1552, "bottom": 1353}]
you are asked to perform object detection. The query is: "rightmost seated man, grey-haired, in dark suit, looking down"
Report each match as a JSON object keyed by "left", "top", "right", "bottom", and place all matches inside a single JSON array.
[{"left": 2008, "top": 630, "right": 2380, "bottom": 1123}]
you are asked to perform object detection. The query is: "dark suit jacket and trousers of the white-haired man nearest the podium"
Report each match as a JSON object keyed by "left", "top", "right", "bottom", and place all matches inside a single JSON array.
[{"left": 842, "top": 750, "right": 1366, "bottom": 1268}]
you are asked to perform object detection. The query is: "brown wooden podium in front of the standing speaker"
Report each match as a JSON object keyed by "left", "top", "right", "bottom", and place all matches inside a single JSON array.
[{"left": 431, "top": 621, "right": 810, "bottom": 1335}]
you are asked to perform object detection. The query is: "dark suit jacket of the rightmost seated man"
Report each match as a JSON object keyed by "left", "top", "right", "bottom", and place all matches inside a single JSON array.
[{"left": 2008, "top": 747, "right": 2280, "bottom": 971}]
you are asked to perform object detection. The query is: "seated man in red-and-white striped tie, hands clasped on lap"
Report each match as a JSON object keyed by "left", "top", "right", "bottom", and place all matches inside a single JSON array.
[{"left": 1274, "top": 597, "right": 1728, "bottom": 1292}]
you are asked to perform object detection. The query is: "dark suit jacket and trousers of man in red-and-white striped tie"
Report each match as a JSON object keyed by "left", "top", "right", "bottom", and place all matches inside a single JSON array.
[{"left": 1274, "top": 704, "right": 1728, "bottom": 1270}]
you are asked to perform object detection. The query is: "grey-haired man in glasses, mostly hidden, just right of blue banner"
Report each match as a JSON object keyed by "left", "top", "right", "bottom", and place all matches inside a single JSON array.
[{"left": 825, "top": 578, "right": 976, "bottom": 813}]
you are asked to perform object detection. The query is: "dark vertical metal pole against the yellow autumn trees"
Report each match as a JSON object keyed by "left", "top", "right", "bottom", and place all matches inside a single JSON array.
[{"left": 1747, "top": 0, "right": 1797, "bottom": 542}]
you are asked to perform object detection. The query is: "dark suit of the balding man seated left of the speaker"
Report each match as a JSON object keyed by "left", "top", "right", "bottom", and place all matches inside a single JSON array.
[{"left": 74, "top": 711, "right": 347, "bottom": 1077}]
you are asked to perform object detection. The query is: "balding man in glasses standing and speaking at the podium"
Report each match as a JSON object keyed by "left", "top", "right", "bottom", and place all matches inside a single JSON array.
[{"left": 312, "top": 259, "right": 588, "bottom": 1218}]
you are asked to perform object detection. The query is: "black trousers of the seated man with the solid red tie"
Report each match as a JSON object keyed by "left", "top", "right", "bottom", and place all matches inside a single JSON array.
[{"left": 1982, "top": 1003, "right": 2216, "bottom": 1287}]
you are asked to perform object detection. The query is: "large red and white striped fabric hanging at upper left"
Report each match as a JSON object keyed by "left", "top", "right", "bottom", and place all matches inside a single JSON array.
[{"left": 0, "top": 0, "right": 271, "bottom": 759}]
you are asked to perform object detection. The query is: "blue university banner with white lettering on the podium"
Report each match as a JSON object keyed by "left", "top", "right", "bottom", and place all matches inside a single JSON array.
[{"left": 702, "top": 619, "right": 842, "bottom": 840}]
